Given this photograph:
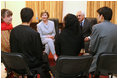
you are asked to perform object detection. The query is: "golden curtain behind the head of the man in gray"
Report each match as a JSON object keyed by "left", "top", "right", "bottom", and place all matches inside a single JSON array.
[{"left": 87, "top": 1, "right": 117, "bottom": 24}]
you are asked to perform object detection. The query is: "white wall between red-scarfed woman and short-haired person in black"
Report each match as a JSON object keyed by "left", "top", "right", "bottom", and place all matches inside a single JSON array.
[{"left": 6, "top": 1, "right": 25, "bottom": 27}]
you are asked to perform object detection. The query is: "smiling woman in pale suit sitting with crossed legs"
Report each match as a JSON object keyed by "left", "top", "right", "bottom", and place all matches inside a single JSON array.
[{"left": 37, "top": 11, "right": 57, "bottom": 61}]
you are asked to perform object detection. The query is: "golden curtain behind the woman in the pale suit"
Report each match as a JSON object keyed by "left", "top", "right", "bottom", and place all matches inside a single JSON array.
[{"left": 26, "top": 1, "right": 63, "bottom": 22}]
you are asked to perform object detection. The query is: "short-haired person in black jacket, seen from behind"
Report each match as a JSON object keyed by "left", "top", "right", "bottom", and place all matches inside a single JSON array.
[{"left": 10, "top": 8, "right": 50, "bottom": 77}]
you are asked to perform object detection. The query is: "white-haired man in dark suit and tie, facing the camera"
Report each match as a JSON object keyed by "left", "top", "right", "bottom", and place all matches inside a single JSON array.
[{"left": 77, "top": 11, "right": 92, "bottom": 53}]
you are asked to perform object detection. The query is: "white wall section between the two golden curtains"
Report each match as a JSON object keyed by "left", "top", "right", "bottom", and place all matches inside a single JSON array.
[{"left": 63, "top": 1, "right": 87, "bottom": 17}]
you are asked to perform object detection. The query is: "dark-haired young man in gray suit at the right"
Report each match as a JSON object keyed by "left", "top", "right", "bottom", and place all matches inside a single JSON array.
[{"left": 89, "top": 7, "right": 117, "bottom": 72}]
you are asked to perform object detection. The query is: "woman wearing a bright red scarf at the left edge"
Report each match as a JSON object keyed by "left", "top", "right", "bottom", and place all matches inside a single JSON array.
[{"left": 1, "top": 9, "right": 13, "bottom": 52}]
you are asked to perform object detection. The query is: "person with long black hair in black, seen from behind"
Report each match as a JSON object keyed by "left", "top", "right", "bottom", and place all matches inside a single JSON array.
[{"left": 55, "top": 14, "right": 84, "bottom": 56}]
